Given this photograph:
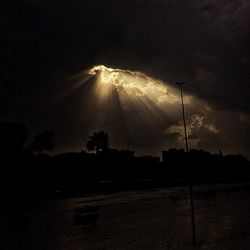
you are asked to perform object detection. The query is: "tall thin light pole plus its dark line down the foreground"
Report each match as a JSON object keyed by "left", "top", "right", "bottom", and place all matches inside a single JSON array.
[{"left": 176, "top": 82, "right": 196, "bottom": 245}]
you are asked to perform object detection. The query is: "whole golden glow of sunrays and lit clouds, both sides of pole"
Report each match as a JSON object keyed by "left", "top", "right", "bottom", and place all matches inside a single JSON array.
[{"left": 84, "top": 65, "right": 223, "bottom": 152}]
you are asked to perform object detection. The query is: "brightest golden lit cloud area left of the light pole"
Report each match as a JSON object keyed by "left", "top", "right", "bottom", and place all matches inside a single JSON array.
[{"left": 88, "top": 65, "right": 184, "bottom": 107}]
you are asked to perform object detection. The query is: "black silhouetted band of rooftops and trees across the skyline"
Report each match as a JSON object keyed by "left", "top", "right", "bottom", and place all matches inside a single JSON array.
[{"left": 0, "top": 122, "right": 250, "bottom": 199}]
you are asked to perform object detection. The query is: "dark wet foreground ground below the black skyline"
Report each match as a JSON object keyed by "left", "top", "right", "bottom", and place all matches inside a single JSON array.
[{"left": 0, "top": 184, "right": 250, "bottom": 250}]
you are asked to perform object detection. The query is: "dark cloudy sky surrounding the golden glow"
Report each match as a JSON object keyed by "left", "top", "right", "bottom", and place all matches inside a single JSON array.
[{"left": 0, "top": 0, "right": 250, "bottom": 156}]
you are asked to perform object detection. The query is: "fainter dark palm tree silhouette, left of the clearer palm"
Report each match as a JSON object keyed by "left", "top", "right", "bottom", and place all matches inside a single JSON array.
[{"left": 29, "top": 130, "right": 55, "bottom": 155}]
